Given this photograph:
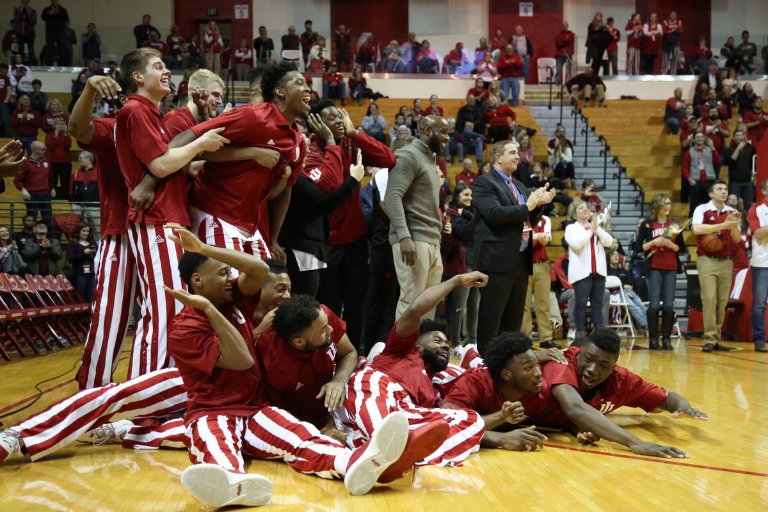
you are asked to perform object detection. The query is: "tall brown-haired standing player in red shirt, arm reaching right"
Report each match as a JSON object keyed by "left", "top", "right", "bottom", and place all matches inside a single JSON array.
[{"left": 115, "top": 48, "right": 228, "bottom": 378}]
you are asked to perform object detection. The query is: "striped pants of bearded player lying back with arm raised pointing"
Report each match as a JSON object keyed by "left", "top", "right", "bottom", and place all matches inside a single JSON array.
[{"left": 337, "top": 367, "right": 485, "bottom": 466}]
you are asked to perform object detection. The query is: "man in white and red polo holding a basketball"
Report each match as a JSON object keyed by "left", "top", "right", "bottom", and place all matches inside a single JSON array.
[{"left": 692, "top": 179, "right": 741, "bottom": 352}]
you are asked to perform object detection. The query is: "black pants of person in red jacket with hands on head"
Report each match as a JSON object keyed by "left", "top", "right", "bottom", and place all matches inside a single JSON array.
[{"left": 317, "top": 237, "right": 368, "bottom": 347}]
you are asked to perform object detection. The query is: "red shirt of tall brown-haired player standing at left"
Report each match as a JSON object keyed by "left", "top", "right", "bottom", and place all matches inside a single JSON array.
[{"left": 116, "top": 94, "right": 191, "bottom": 226}]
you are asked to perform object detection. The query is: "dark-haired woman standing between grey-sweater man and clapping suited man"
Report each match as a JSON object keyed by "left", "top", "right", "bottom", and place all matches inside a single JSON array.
[{"left": 440, "top": 181, "right": 480, "bottom": 347}]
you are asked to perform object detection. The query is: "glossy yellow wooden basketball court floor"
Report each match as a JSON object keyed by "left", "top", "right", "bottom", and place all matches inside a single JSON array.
[{"left": 0, "top": 340, "right": 768, "bottom": 512}]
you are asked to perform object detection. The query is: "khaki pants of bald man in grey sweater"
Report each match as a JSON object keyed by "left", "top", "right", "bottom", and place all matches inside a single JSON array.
[{"left": 392, "top": 242, "right": 443, "bottom": 321}]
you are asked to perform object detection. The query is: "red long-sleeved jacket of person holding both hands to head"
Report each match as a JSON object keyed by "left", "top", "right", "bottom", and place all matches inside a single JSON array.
[{"left": 304, "top": 132, "right": 395, "bottom": 245}]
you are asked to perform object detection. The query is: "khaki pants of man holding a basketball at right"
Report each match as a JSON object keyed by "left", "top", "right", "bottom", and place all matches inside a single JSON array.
[{"left": 696, "top": 256, "right": 733, "bottom": 343}]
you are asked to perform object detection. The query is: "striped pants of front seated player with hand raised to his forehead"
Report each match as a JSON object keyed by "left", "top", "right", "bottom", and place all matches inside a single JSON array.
[{"left": 187, "top": 407, "right": 352, "bottom": 478}]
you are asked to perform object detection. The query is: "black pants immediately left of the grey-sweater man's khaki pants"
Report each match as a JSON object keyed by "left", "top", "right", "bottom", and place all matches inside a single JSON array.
[{"left": 361, "top": 245, "right": 400, "bottom": 354}]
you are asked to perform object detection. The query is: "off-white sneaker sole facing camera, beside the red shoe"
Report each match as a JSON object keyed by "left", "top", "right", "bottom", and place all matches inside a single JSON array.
[{"left": 344, "top": 412, "right": 408, "bottom": 496}]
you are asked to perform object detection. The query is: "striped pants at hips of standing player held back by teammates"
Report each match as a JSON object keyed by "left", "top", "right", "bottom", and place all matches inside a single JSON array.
[{"left": 189, "top": 207, "right": 272, "bottom": 262}]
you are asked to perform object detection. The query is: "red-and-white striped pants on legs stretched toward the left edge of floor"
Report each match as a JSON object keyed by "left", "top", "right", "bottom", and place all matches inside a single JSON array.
[{"left": 11, "top": 368, "right": 187, "bottom": 461}]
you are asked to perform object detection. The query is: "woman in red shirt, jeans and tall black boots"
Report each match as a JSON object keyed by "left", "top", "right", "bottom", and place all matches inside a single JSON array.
[{"left": 635, "top": 194, "right": 685, "bottom": 350}]
